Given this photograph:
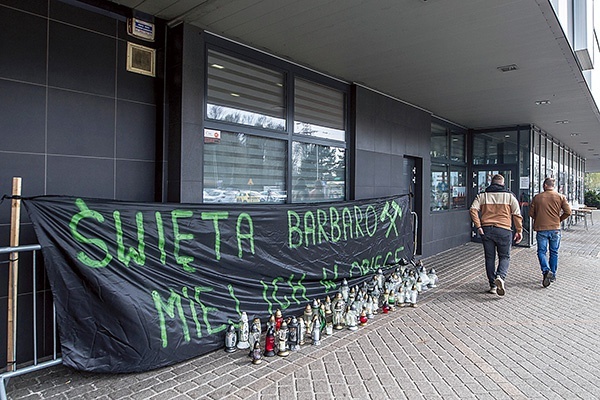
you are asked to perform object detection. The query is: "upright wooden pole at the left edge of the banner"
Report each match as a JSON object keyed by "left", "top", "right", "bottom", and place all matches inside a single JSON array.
[{"left": 6, "top": 177, "right": 21, "bottom": 371}]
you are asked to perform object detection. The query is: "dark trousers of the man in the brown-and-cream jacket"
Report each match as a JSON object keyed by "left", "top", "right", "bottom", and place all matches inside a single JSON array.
[{"left": 481, "top": 226, "right": 512, "bottom": 287}]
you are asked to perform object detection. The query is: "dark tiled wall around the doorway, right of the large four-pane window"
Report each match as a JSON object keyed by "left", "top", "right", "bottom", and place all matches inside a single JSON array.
[{"left": 353, "top": 87, "right": 471, "bottom": 256}]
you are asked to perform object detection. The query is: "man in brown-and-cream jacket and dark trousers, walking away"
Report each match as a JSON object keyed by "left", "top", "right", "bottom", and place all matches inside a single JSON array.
[{"left": 469, "top": 174, "right": 523, "bottom": 296}]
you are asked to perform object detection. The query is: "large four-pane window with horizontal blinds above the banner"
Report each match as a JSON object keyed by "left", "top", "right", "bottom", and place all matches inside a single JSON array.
[{"left": 203, "top": 46, "right": 349, "bottom": 203}]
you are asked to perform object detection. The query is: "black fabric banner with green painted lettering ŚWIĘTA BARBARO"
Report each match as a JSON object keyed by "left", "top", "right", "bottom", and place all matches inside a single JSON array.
[{"left": 23, "top": 196, "right": 413, "bottom": 372}]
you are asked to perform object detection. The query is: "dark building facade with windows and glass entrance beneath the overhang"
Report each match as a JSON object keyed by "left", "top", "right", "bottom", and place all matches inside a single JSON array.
[{"left": 0, "top": 0, "right": 600, "bottom": 364}]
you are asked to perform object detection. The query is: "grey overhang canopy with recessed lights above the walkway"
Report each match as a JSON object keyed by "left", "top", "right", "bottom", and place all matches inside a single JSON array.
[{"left": 113, "top": 0, "right": 600, "bottom": 171}]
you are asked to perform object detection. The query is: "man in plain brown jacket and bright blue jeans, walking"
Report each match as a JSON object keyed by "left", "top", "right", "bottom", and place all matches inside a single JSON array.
[{"left": 529, "top": 178, "right": 571, "bottom": 287}]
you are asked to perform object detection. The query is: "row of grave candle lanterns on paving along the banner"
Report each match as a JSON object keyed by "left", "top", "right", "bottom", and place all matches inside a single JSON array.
[{"left": 225, "top": 261, "right": 438, "bottom": 364}]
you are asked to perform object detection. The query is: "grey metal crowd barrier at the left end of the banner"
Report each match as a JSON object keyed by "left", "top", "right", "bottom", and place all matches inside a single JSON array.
[{"left": 0, "top": 244, "right": 62, "bottom": 400}]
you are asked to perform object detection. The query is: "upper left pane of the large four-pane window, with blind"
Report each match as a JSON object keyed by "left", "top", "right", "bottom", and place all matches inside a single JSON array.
[{"left": 206, "top": 50, "right": 286, "bottom": 131}]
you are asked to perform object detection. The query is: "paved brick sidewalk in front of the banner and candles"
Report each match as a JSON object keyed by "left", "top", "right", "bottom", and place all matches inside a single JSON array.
[{"left": 7, "top": 211, "right": 600, "bottom": 400}]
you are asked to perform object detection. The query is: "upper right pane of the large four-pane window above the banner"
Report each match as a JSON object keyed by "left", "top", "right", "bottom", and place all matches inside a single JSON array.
[{"left": 294, "top": 78, "right": 346, "bottom": 140}]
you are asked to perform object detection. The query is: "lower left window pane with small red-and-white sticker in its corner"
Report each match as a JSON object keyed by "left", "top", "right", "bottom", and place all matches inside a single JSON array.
[{"left": 203, "top": 130, "right": 287, "bottom": 203}]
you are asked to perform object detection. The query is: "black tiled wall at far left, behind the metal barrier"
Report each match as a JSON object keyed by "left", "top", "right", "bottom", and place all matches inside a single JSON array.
[{"left": 0, "top": 0, "right": 165, "bottom": 365}]
